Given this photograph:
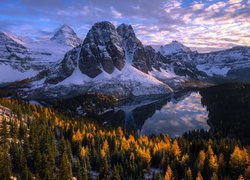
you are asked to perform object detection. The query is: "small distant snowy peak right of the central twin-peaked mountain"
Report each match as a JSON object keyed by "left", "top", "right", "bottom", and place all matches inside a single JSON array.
[{"left": 160, "top": 40, "right": 191, "bottom": 56}]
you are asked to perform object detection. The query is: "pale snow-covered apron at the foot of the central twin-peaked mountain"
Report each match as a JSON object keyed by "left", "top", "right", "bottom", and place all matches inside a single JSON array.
[{"left": 53, "top": 65, "right": 173, "bottom": 96}]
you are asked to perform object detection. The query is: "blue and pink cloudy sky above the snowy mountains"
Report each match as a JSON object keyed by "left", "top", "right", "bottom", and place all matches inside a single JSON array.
[{"left": 0, "top": 0, "right": 250, "bottom": 52}]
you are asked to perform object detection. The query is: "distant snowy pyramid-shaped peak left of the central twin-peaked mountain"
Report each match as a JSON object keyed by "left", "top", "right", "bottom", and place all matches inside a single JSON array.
[{"left": 50, "top": 24, "right": 81, "bottom": 47}]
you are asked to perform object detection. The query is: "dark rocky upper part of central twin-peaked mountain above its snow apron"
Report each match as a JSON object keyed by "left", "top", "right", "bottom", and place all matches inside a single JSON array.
[{"left": 43, "top": 21, "right": 201, "bottom": 84}]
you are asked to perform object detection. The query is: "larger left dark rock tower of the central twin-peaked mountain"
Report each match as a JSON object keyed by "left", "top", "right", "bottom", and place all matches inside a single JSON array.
[{"left": 79, "top": 22, "right": 125, "bottom": 78}]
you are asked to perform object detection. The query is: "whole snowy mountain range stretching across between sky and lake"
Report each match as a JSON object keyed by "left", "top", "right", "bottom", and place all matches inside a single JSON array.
[{"left": 0, "top": 21, "right": 250, "bottom": 98}]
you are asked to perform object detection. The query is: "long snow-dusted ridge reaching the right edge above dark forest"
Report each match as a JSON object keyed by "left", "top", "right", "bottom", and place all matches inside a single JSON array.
[{"left": 160, "top": 46, "right": 250, "bottom": 83}]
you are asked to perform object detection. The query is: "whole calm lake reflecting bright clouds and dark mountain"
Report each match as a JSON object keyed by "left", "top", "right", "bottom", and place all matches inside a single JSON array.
[{"left": 101, "top": 92, "right": 209, "bottom": 137}]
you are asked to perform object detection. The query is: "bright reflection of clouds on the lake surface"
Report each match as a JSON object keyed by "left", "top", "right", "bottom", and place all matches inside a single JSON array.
[{"left": 140, "top": 92, "right": 209, "bottom": 137}]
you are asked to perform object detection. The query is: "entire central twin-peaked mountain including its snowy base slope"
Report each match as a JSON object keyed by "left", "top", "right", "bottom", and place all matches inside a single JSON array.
[{"left": 34, "top": 21, "right": 172, "bottom": 96}]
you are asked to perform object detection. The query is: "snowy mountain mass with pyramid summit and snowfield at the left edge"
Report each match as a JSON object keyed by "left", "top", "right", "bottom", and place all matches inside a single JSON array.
[{"left": 0, "top": 26, "right": 80, "bottom": 83}]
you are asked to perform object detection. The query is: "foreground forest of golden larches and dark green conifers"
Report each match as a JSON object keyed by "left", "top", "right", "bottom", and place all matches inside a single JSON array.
[{"left": 0, "top": 99, "right": 250, "bottom": 180}]
